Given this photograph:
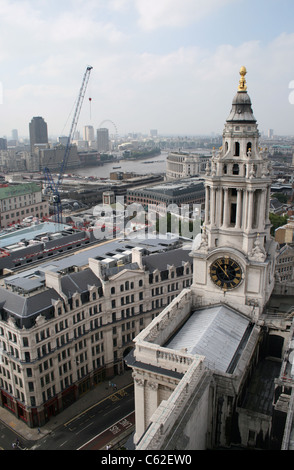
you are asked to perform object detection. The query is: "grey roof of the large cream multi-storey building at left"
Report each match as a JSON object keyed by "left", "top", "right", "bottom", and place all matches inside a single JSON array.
[{"left": 0, "top": 239, "right": 189, "bottom": 327}]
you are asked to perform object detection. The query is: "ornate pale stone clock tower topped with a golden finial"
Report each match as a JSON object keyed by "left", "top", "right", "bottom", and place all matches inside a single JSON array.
[{"left": 191, "top": 67, "right": 276, "bottom": 320}]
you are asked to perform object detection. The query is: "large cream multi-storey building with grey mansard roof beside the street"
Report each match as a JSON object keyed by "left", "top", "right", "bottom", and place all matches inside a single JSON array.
[{"left": 0, "top": 238, "right": 192, "bottom": 427}]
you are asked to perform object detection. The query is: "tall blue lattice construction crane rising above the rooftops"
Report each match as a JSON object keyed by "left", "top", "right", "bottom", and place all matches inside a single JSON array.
[{"left": 44, "top": 65, "right": 93, "bottom": 223}]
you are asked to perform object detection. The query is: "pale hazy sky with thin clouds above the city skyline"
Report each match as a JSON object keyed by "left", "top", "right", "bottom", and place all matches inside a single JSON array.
[{"left": 0, "top": 0, "right": 294, "bottom": 139}]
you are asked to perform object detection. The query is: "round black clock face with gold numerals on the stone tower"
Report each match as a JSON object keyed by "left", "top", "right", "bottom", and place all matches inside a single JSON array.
[{"left": 210, "top": 256, "right": 242, "bottom": 290}]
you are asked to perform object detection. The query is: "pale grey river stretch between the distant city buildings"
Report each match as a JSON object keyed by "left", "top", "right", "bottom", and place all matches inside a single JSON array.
[{"left": 74, "top": 152, "right": 168, "bottom": 178}]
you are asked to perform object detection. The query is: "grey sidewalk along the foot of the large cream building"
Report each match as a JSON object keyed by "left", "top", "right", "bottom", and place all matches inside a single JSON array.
[{"left": 0, "top": 371, "right": 133, "bottom": 441}]
